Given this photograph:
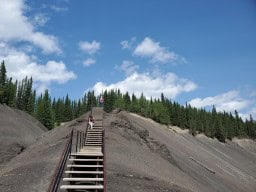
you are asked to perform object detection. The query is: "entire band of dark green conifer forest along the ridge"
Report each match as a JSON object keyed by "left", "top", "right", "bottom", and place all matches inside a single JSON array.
[{"left": 0, "top": 61, "right": 256, "bottom": 142}]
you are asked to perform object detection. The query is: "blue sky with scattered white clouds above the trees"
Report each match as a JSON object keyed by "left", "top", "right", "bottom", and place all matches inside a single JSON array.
[{"left": 0, "top": 0, "right": 256, "bottom": 119}]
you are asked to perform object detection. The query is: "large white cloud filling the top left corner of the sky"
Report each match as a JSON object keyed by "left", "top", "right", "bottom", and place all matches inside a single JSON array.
[{"left": 0, "top": 0, "right": 61, "bottom": 53}]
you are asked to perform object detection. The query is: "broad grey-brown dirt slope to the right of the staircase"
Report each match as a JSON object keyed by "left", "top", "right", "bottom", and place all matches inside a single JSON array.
[{"left": 104, "top": 112, "right": 256, "bottom": 192}]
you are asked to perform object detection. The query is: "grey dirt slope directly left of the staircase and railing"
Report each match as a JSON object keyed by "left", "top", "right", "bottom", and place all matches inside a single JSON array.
[{"left": 0, "top": 109, "right": 87, "bottom": 192}]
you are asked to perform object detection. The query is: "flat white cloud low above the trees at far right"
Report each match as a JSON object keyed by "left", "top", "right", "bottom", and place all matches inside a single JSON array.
[{"left": 189, "top": 91, "right": 250, "bottom": 112}]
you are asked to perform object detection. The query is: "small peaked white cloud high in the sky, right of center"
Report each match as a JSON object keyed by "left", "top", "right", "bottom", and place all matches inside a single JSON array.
[{"left": 133, "top": 37, "right": 179, "bottom": 63}]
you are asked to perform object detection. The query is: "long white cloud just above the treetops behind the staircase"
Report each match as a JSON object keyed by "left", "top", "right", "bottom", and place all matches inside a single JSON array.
[{"left": 89, "top": 72, "right": 197, "bottom": 99}]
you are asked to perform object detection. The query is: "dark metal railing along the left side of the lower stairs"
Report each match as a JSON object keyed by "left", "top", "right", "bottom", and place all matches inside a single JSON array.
[{"left": 48, "top": 129, "right": 73, "bottom": 192}]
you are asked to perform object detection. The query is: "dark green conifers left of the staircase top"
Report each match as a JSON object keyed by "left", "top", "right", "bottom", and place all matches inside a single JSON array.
[{"left": 0, "top": 61, "right": 97, "bottom": 129}]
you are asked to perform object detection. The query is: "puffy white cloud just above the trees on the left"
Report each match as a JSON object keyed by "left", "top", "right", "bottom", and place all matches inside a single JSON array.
[{"left": 0, "top": 43, "right": 76, "bottom": 91}]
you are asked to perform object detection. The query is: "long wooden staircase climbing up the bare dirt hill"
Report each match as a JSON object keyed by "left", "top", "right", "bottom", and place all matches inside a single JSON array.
[{"left": 60, "top": 108, "right": 105, "bottom": 192}]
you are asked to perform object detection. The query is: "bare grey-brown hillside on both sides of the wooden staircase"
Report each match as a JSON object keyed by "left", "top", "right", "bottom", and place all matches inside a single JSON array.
[{"left": 0, "top": 107, "right": 256, "bottom": 192}]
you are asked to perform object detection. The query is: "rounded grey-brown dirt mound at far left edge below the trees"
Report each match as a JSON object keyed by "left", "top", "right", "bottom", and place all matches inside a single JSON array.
[{"left": 0, "top": 105, "right": 47, "bottom": 166}]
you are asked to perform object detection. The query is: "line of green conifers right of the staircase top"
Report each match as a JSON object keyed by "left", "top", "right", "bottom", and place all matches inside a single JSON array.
[{"left": 103, "top": 90, "right": 256, "bottom": 142}]
